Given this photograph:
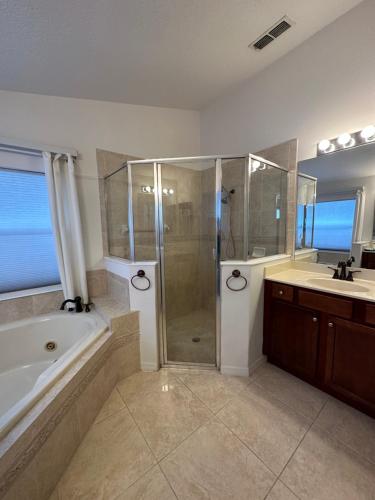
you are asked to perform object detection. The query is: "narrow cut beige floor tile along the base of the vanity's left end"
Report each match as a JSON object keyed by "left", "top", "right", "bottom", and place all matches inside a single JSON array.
[{"left": 254, "top": 363, "right": 328, "bottom": 420}]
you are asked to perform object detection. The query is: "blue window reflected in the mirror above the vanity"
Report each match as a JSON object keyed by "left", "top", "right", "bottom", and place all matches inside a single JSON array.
[{"left": 314, "top": 199, "right": 356, "bottom": 251}]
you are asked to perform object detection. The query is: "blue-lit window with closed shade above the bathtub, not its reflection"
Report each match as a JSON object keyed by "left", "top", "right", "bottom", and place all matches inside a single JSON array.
[{"left": 0, "top": 168, "right": 60, "bottom": 293}]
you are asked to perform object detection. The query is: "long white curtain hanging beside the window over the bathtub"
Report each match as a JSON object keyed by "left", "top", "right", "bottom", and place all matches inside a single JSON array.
[{"left": 43, "top": 152, "right": 88, "bottom": 304}]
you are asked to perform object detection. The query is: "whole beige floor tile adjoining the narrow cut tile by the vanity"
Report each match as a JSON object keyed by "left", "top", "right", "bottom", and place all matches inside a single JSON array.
[{"left": 217, "top": 384, "right": 310, "bottom": 474}]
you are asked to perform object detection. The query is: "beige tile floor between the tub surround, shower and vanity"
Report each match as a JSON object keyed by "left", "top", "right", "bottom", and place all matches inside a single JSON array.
[{"left": 51, "top": 364, "right": 375, "bottom": 500}]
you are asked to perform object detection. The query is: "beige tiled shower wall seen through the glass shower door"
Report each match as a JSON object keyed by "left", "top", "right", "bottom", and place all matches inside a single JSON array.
[{"left": 162, "top": 165, "right": 215, "bottom": 320}]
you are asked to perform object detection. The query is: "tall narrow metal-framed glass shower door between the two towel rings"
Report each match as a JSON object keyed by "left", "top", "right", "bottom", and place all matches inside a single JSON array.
[{"left": 158, "top": 159, "right": 217, "bottom": 365}]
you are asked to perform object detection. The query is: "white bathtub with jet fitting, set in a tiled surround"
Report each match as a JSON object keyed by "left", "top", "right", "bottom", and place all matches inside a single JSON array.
[{"left": 0, "top": 312, "right": 107, "bottom": 437}]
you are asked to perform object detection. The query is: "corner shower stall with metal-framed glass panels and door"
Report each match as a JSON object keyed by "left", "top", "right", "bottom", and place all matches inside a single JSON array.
[{"left": 105, "top": 154, "right": 288, "bottom": 366}]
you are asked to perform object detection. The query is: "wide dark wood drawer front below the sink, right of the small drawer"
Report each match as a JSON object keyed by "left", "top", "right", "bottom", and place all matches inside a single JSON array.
[{"left": 298, "top": 289, "right": 353, "bottom": 319}]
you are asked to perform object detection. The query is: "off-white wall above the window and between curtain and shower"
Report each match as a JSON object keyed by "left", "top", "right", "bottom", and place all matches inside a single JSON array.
[{"left": 0, "top": 91, "right": 200, "bottom": 269}]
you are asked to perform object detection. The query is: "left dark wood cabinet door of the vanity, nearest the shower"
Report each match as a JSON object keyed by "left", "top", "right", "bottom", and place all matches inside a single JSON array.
[{"left": 268, "top": 301, "right": 319, "bottom": 380}]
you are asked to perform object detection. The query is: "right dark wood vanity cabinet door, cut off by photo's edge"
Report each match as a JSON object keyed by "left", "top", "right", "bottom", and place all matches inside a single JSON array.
[{"left": 325, "top": 318, "right": 375, "bottom": 413}]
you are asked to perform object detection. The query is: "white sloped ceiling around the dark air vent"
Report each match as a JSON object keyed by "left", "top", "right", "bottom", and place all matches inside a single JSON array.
[{"left": 0, "top": 0, "right": 360, "bottom": 109}]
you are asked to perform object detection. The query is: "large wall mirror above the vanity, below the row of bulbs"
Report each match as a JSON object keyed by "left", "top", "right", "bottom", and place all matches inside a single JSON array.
[{"left": 295, "top": 144, "right": 375, "bottom": 269}]
